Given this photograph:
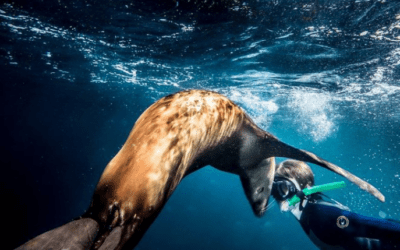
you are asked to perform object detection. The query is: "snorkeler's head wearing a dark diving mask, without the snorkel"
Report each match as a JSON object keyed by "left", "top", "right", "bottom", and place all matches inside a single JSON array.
[{"left": 271, "top": 160, "right": 314, "bottom": 211}]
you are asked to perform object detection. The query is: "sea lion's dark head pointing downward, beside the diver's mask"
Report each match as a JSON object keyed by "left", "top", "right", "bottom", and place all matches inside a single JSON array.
[{"left": 240, "top": 157, "right": 275, "bottom": 217}]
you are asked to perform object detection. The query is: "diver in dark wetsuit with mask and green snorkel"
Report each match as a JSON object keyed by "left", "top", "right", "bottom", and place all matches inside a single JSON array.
[{"left": 272, "top": 160, "right": 400, "bottom": 250}]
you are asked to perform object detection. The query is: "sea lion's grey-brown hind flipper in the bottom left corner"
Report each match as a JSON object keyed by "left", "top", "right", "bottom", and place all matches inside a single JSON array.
[{"left": 15, "top": 218, "right": 99, "bottom": 250}]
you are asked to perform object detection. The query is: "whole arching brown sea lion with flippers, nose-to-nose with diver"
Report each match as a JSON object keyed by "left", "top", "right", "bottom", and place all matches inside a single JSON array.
[{"left": 19, "top": 90, "right": 384, "bottom": 249}]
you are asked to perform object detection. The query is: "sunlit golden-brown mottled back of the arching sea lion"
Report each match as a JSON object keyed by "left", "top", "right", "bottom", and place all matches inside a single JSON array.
[{"left": 92, "top": 90, "right": 251, "bottom": 224}]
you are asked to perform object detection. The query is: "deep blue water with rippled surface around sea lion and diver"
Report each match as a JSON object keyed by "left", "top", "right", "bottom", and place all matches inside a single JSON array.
[{"left": 0, "top": 0, "right": 400, "bottom": 250}]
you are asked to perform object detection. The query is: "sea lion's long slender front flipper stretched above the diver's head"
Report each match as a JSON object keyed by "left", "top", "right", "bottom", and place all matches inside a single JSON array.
[{"left": 268, "top": 138, "right": 385, "bottom": 202}]
